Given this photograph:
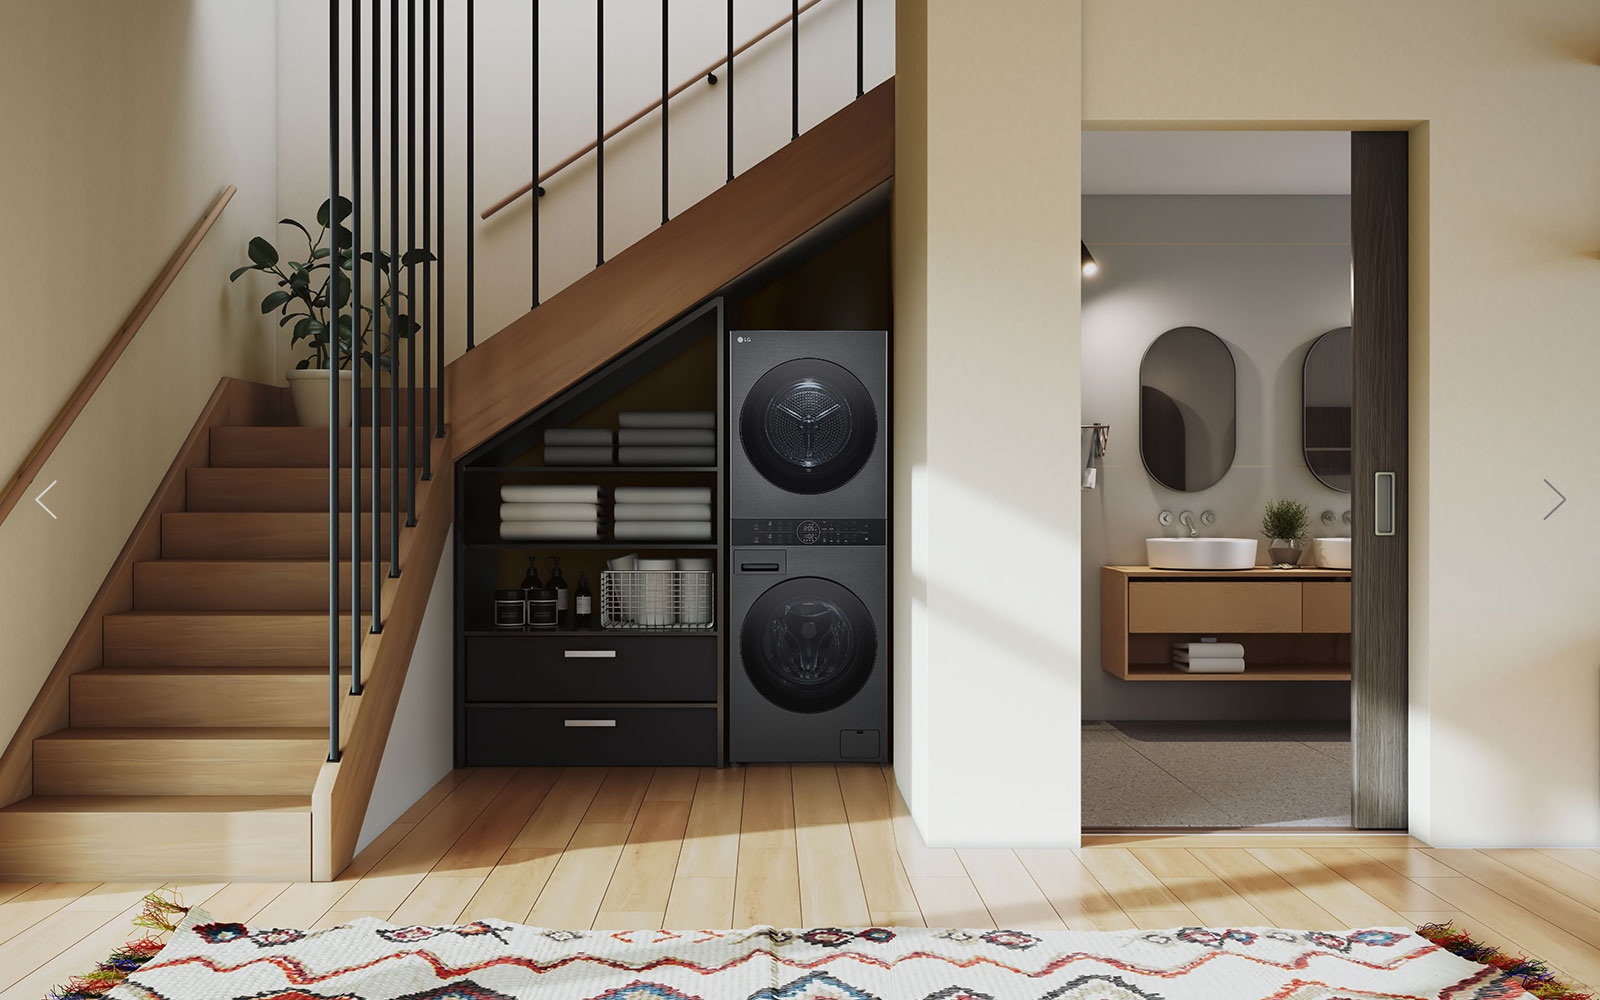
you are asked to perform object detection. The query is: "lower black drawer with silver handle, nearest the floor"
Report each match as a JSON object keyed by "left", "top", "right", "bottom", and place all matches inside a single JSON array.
[{"left": 467, "top": 706, "right": 717, "bottom": 766}]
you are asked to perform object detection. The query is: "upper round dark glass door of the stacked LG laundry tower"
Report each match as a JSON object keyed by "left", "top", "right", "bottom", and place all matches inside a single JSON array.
[{"left": 739, "top": 358, "right": 878, "bottom": 494}]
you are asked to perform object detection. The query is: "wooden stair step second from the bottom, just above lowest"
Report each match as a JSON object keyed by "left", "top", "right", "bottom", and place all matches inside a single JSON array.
[{"left": 34, "top": 726, "right": 328, "bottom": 795}]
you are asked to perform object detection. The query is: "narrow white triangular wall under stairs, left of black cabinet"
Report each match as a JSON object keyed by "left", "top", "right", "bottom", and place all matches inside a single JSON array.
[{"left": 355, "top": 528, "right": 456, "bottom": 853}]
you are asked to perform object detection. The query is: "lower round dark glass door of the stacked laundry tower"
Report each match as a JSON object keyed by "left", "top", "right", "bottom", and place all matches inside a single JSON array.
[{"left": 739, "top": 576, "right": 878, "bottom": 712}]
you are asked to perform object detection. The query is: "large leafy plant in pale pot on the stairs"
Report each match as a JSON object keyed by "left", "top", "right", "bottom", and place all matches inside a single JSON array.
[{"left": 227, "top": 197, "right": 434, "bottom": 427}]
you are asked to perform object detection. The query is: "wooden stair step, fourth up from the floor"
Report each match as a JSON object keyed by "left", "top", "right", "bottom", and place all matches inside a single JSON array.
[{"left": 102, "top": 611, "right": 370, "bottom": 667}]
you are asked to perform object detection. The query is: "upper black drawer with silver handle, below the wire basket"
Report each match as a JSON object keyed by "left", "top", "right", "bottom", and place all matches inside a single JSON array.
[{"left": 467, "top": 634, "right": 718, "bottom": 702}]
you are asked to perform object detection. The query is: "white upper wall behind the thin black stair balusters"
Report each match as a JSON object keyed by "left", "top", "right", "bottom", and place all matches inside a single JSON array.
[{"left": 277, "top": 0, "right": 894, "bottom": 380}]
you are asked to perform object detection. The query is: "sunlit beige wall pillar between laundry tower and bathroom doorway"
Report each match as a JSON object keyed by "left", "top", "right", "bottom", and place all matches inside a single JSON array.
[{"left": 893, "top": 0, "right": 1080, "bottom": 846}]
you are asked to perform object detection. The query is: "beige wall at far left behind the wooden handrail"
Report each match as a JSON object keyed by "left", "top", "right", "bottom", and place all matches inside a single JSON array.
[{"left": 0, "top": 0, "right": 277, "bottom": 739}]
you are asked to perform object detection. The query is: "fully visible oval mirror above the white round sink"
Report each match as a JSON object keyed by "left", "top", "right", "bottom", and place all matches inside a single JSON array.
[{"left": 1139, "top": 326, "right": 1237, "bottom": 493}]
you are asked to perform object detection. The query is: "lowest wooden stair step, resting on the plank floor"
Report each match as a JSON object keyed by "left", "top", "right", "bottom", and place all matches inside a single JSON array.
[{"left": 0, "top": 794, "right": 310, "bottom": 882}]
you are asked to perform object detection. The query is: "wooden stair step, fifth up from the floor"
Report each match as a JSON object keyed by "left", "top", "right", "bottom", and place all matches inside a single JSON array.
[{"left": 133, "top": 555, "right": 376, "bottom": 611}]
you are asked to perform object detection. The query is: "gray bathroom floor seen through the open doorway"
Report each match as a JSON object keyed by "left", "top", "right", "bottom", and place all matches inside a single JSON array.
[{"left": 1083, "top": 722, "right": 1350, "bottom": 829}]
